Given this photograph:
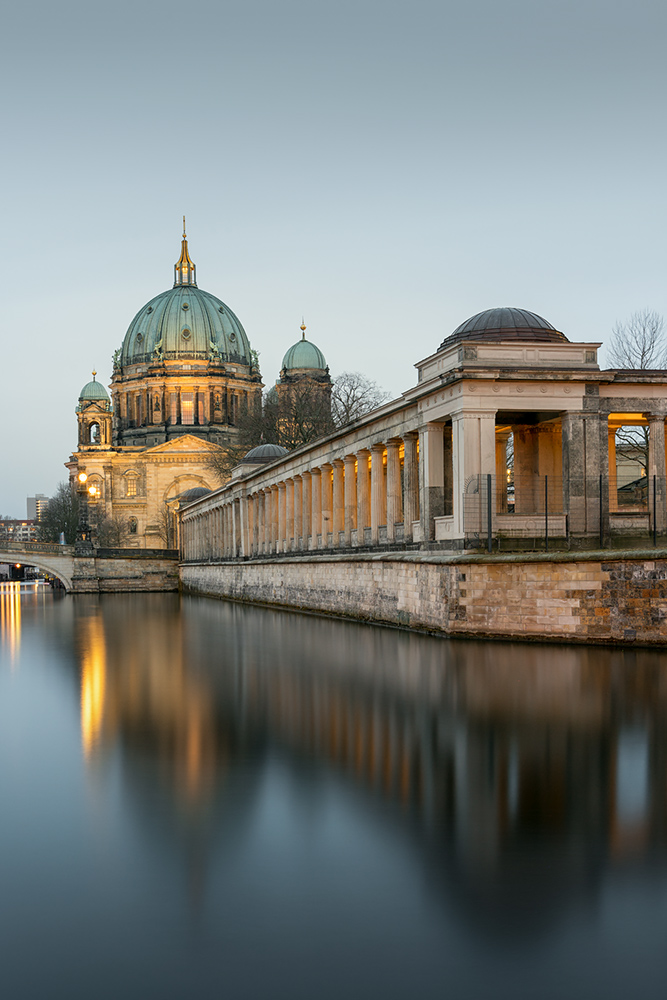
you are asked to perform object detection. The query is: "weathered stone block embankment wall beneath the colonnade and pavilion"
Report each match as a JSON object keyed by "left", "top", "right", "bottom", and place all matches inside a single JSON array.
[{"left": 181, "top": 550, "right": 667, "bottom": 645}]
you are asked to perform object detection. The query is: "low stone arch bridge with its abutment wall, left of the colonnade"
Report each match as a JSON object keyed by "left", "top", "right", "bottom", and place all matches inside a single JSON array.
[{"left": 0, "top": 542, "right": 178, "bottom": 593}]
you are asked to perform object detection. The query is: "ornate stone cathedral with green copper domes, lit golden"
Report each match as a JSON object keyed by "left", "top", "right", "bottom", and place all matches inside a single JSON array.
[{"left": 66, "top": 227, "right": 331, "bottom": 548}]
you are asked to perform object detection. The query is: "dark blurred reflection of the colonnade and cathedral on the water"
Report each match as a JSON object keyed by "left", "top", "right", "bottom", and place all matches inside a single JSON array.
[{"left": 66, "top": 597, "right": 667, "bottom": 936}]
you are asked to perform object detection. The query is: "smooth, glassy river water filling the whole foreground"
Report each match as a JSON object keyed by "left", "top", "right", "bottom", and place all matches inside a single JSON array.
[{"left": 0, "top": 585, "right": 667, "bottom": 1000}]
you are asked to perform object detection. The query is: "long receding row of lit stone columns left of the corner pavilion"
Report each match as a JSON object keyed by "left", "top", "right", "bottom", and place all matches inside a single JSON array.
[{"left": 182, "top": 432, "right": 419, "bottom": 560}]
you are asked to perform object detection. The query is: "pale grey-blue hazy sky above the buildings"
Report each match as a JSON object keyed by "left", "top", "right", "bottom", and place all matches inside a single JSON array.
[{"left": 0, "top": 0, "right": 667, "bottom": 517}]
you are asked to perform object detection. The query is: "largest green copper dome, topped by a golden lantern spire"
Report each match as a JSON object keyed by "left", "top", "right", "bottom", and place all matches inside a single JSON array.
[{"left": 118, "top": 233, "right": 253, "bottom": 367}]
